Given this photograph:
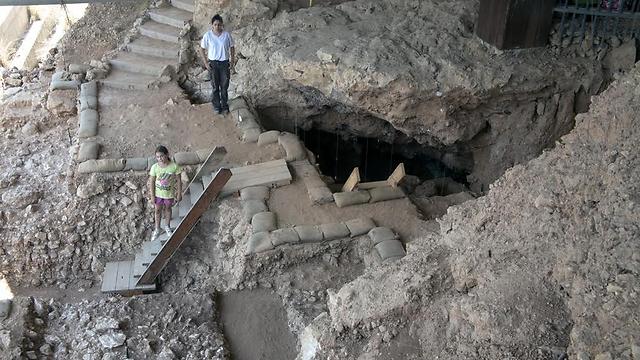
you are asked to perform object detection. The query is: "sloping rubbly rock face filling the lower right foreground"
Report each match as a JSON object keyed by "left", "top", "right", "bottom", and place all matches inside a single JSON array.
[{"left": 308, "top": 66, "right": 640, "bottom": 359}]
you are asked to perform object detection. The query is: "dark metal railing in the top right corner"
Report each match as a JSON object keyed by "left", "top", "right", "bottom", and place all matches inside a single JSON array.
[{"left": 553, "top": 0, "right": 640, "bottom": 40}]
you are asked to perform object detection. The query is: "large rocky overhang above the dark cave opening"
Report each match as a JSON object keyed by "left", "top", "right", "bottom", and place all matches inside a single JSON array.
[{"left": 188, "top": 0, "right": 602, "bottom": 191}]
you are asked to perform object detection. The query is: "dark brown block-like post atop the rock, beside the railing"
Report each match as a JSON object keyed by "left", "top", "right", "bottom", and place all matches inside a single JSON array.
[{"left": 476, "top": 0, "right": 555, "bottom": 50}]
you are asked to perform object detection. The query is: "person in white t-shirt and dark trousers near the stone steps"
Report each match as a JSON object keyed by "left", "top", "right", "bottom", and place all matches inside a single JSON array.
[{"left": 200, "top": 14, "right": 236, "bottom": 114}]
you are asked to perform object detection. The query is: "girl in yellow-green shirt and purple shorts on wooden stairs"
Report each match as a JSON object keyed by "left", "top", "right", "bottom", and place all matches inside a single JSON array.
[{"left": 148, "top": 145, "right": 182, "bottom": 240}]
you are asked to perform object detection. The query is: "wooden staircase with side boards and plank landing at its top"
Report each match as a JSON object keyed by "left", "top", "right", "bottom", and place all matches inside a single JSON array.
[{"left": 102, "top": 155, "right": 291, "bottom": 296}]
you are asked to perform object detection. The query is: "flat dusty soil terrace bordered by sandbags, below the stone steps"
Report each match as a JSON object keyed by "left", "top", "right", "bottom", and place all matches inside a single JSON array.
[{"left": 98, "top": 83, "right": 284, "bottom": 165}]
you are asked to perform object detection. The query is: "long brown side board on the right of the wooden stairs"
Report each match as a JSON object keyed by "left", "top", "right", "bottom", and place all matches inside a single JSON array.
[{"left": 136, "top": 168, "right": 231, "bottom": 286}]
